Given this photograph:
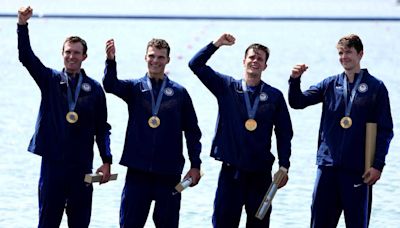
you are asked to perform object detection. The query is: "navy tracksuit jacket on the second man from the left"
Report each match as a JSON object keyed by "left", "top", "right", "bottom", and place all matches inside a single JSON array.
[{"left": 103, "top": 60, "right": 201, "bottom": 175}]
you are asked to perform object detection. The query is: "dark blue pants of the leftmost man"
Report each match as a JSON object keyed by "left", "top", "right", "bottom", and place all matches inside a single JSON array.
[{"left": 38, "top": 159, "right": 93, "bottom": 228}]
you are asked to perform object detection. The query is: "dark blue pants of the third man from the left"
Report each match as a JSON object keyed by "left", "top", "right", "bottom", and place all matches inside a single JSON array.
[{"left": 212, "top": 164, "right": 271, "bottom": 228}]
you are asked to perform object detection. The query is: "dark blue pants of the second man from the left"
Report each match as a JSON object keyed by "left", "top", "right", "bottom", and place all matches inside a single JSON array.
[{"left": 120, "top": 169, "right": 181, "bottom": 228}]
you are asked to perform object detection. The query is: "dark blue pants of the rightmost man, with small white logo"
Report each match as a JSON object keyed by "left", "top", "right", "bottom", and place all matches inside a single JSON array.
[{"left": 311, "top": 166, "right": 369, "bottom": 228}]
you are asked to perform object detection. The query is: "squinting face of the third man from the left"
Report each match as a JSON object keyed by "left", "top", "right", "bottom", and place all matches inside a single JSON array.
[{"left": 243, "top": 49, "right": 267, "bottom": 77}]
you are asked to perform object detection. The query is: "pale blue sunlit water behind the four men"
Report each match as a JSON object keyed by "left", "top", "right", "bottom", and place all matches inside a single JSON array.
[{"left": 0, "top": 1, "right": 400, "bottom": 228}]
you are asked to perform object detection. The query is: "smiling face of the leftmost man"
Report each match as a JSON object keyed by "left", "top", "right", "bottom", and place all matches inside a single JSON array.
[{"left": 62, "top": 42, "right": 87, "bottom": 74}]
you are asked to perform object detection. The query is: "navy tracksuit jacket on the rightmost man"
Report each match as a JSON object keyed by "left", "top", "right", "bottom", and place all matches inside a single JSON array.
[{"left": 289, "top": 69, "right": 393, "bottom": 175}]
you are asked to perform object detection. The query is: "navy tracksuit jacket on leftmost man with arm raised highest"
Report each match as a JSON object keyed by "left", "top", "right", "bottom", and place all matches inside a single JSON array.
[{"left": 18, "top": 26, "right": 112, "bottom": 169}]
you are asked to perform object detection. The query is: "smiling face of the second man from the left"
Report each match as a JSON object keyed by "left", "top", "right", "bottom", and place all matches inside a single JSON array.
[{"left": 145, "top": 46, "right": 169, "bottom": 77}]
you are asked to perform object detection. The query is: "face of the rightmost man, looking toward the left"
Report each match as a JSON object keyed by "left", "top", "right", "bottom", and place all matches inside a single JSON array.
[{"left": 337, "top": 46, "right": 363, "bottom": 71}]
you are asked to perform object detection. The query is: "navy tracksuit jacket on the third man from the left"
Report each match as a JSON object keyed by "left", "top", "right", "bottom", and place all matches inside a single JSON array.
[{"left": 189, "top": 43, "right": 293, "bottom": 171}]
